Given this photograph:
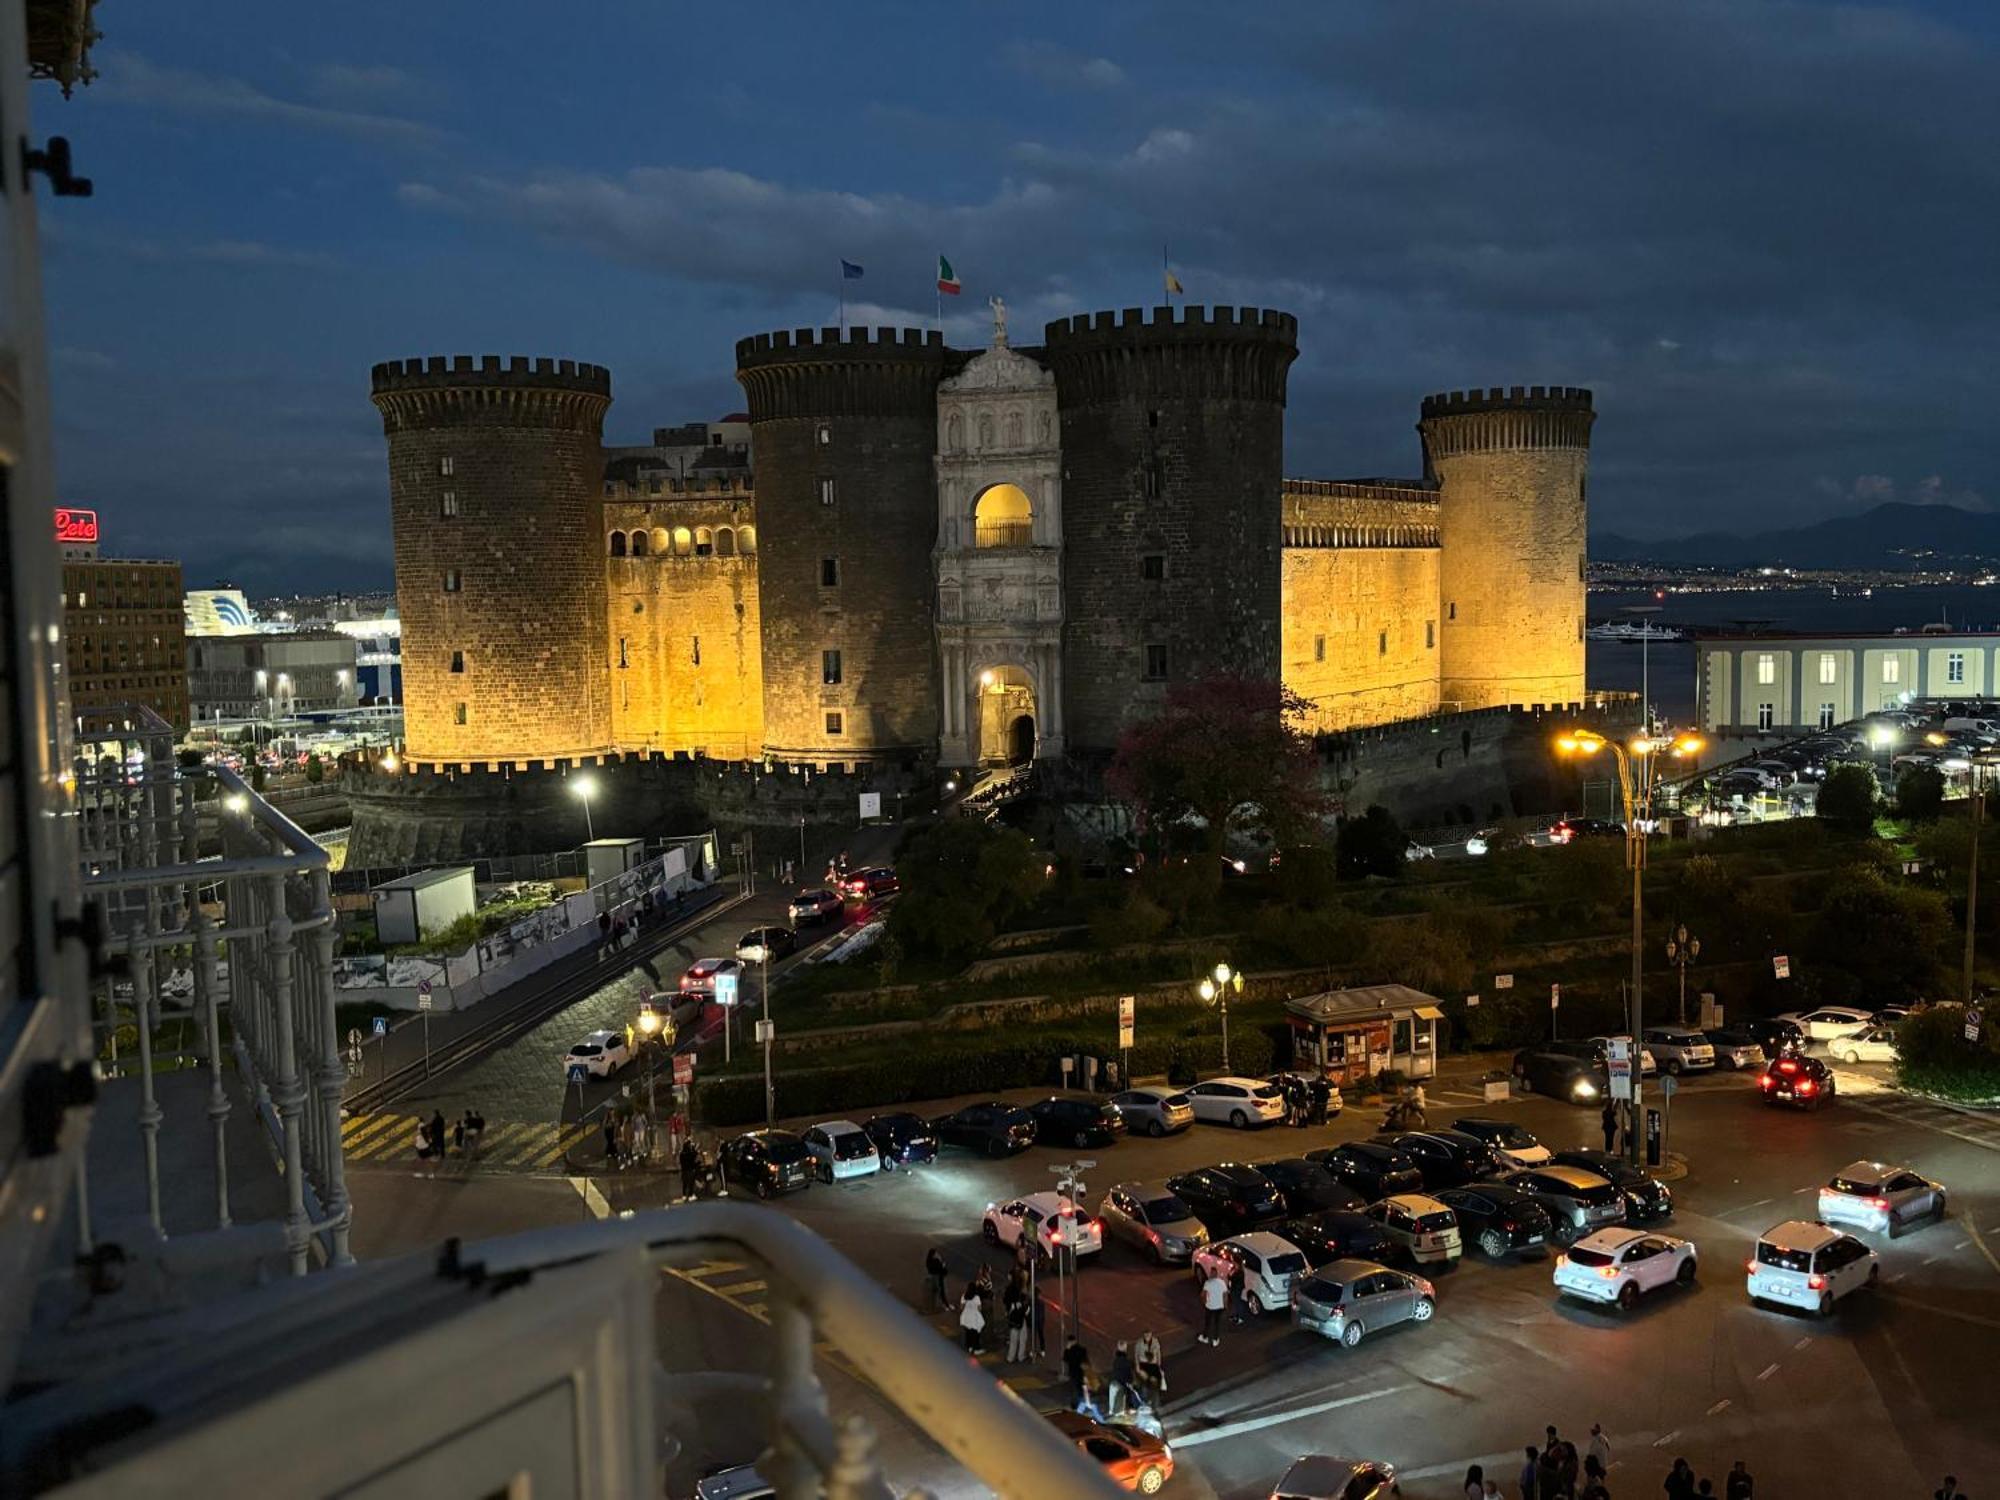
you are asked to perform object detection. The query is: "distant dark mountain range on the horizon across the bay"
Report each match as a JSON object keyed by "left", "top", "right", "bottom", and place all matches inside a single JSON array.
[{"left": 1590, "top": 502, "right": 2000, "bottom": 568}]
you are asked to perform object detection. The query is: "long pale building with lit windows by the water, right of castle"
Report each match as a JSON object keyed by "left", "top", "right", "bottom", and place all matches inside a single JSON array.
[{"left": 1694, "top": 626, "right": 2000, "bottom": 736}]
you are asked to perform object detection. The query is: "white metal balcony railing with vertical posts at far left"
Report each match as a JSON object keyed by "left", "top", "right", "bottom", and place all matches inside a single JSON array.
[{"left": 76, "top": 706, "right": 352, "bottom": 1274}]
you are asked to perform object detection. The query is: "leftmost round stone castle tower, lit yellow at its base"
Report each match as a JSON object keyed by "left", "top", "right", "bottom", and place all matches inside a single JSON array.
[{"left": 374, "top": 354, "right": 612, "bottom": 764}]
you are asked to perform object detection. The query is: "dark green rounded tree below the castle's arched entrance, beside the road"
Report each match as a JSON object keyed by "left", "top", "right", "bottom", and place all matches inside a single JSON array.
[{"left": 888, "top": 818, "right": 1048, "bottom": 958}]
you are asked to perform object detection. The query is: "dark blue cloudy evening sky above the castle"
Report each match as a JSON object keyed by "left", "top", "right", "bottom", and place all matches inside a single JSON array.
[{"left": 36, "top": 0, "right": 2000, "bottom": 590}]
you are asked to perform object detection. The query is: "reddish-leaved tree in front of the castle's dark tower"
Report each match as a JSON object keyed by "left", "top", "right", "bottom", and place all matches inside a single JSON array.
[{"left": 1108, "top": 676, "right": 1324, "bottom": 882}]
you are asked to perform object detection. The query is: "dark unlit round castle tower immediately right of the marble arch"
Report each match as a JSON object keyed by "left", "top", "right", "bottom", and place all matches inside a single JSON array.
[{"left": 1044, "top": 308, "right": 1298, "bottom": 750}]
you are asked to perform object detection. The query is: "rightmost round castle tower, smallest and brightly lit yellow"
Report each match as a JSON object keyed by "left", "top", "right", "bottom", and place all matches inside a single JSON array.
[{"left": 1418, "top": 386, "right": 1594, "bottom": 708}]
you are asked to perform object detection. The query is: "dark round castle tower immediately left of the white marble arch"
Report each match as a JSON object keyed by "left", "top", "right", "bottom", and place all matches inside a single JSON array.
[{"left": 736, "top": 328, "right": 948, "bottom": 764}]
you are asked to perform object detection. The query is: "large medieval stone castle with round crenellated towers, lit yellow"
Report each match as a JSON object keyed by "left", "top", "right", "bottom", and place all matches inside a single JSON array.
[{"left": 372, "top": 306, "right": 1594, "bottom": 768}]
